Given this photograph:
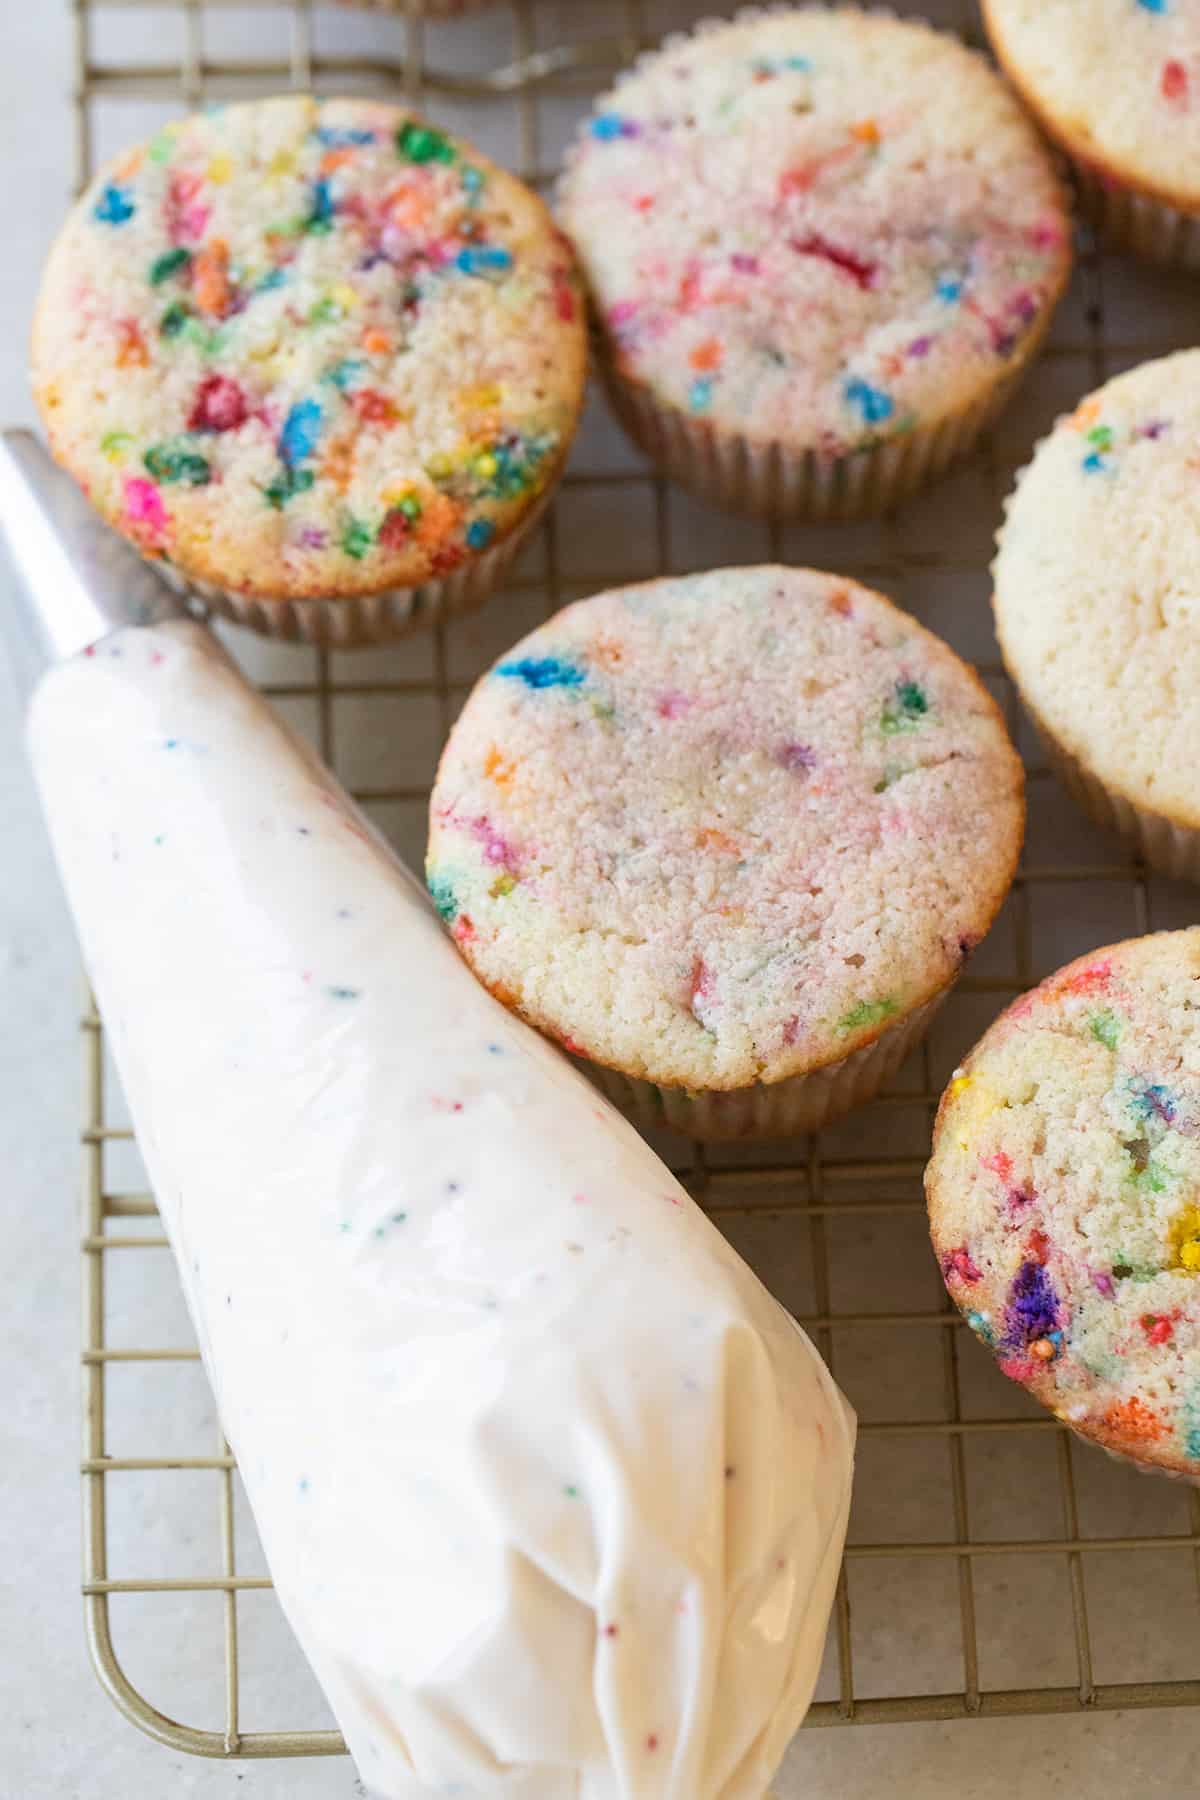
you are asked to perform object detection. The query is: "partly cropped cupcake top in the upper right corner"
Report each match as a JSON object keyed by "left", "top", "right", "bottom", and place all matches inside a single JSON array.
[{"left": 982, "top": 0, "right": 1200, "bottom": 207}]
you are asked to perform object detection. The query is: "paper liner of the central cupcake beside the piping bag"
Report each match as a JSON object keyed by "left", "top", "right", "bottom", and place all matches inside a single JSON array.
[{"left": 576, "top": 988, "right": 950, "bottom": 1143}]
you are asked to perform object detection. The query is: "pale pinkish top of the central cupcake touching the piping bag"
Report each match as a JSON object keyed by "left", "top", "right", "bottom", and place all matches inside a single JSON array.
[{"left": 428, "top": 567, "right": 1024, "bottom": 1091}]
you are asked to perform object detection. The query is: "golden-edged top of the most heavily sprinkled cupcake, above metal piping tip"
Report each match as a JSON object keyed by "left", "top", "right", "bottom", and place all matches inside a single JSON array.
[{"left": 34, "top": 95, "right": 585, "bottom": 598}]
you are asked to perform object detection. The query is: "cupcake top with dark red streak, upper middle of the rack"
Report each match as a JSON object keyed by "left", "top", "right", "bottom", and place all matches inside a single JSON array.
[{"left": 560, "top": 7, "right": 1070, "bottom": 455}]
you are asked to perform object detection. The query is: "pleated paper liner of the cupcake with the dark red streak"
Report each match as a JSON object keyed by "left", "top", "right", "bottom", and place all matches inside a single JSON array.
[{"left": 596, "top": 334, "right": 1054, "bottom": 524}]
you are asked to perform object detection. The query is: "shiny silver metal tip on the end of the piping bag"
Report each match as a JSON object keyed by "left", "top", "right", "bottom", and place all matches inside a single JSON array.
[{"left": 0, "top": 430, "right": 193, "bottom": 686}]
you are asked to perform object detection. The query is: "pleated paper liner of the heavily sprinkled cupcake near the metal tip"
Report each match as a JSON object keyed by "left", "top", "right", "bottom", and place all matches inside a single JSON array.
[{"left": 155, "top": 479, "right": 556, "bottom": 650}]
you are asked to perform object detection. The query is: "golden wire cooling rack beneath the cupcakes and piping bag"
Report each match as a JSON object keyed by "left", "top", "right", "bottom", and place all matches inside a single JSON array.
[{"left": 74, "top": 0, "right": 1200, "bottom": 1771}]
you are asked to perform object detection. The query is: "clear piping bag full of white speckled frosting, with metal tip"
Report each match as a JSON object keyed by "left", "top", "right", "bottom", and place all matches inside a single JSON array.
[{"left": 0, "top": 434, "right": 855, "bottom": 1800}]
